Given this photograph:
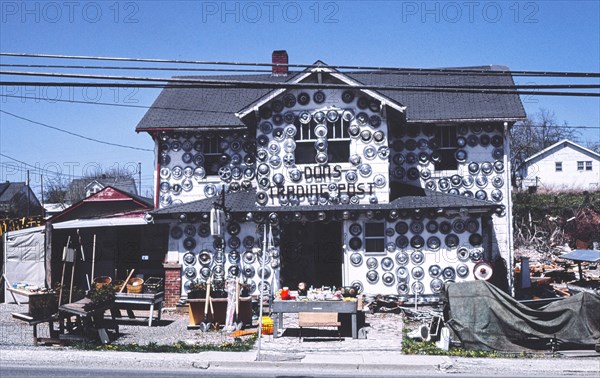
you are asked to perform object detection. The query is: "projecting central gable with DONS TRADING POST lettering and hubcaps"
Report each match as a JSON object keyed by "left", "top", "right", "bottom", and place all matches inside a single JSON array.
[{"left": 237, "top": 61, "right": 405, "bottom": 206}]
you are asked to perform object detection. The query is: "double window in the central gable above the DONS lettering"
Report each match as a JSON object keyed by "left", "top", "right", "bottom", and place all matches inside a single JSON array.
[{"left": 294, "top": 113, "right": 350, "bottom": 164}]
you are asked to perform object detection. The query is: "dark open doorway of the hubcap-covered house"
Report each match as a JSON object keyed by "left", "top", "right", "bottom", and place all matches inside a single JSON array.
[{"left": 281, "top": 221, "right": 343, "bottom": 290}]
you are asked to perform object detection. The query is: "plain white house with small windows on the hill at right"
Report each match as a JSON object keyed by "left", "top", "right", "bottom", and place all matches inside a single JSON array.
[{"left": 521, "top": 139, "right": 600, "bottom": 190}]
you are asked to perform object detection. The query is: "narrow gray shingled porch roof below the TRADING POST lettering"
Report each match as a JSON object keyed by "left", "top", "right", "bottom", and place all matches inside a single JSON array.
[{"left": 151, "top": 188, "right": 498, "bottom": 217}]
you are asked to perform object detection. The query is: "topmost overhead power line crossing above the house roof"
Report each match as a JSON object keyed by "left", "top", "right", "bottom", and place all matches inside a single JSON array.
[{"left": 0, "top": 53, "right": 600, "bottom": 77}]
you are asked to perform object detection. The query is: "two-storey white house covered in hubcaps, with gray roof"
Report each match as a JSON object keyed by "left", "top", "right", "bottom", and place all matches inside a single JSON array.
[{"left": 136, "top": 51, "right": 526, "bottom": 301}]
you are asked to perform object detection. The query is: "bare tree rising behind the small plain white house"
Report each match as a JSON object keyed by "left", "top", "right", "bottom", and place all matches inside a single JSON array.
[{"left": 510, "top": 108, "right": 580, "bottom": 186}]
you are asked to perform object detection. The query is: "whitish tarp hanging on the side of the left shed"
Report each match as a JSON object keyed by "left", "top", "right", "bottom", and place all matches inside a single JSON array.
[{"left": 3, "top": 226, "right": 46, "bottom": 302}]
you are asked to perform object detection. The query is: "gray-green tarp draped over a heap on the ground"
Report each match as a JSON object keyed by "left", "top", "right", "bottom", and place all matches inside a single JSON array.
[{"left": 444, "top": 281, "right": 600, "bottom": 352}]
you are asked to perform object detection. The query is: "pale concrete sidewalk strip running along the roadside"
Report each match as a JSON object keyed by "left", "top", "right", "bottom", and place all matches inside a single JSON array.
[{"left": 0, "top": 348, "right": 600, "bottom": 376}]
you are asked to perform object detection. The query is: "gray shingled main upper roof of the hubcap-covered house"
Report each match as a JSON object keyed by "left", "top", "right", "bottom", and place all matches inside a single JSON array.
[{"left": 136, "top": 66, "right": 526, "bottom": 131}]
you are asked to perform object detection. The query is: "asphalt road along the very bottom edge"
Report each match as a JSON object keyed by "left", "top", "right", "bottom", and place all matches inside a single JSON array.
[{"left": 0, "top": 363, "right": 597, "bottom": 378}]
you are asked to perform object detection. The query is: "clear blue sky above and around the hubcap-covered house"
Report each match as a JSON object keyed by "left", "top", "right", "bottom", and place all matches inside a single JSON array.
[{"left": 0, "top": 0, "right": 600, "bottom": 201}]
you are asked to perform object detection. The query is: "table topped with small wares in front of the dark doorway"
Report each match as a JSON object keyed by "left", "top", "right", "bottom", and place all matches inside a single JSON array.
[{"left": 271, "top": 300, "right": 358, "bottom": 339}]
